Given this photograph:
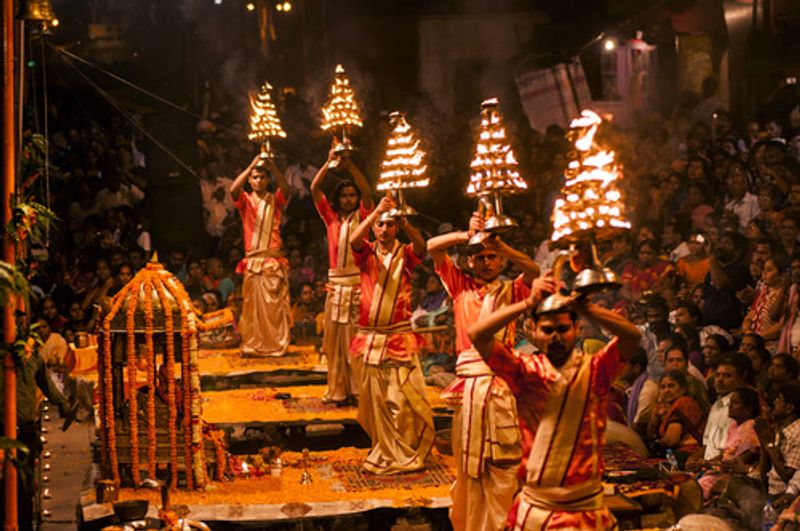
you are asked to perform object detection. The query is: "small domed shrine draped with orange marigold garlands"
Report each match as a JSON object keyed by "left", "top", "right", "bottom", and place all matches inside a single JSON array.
[{"left": 98, "top": 257, "right": 233, "bottom": 489}]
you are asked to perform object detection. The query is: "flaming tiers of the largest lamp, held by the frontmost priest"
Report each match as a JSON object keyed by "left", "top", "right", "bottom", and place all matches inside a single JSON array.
[{"left": 550, "top": 110, "right": 631, "bottom": 243}]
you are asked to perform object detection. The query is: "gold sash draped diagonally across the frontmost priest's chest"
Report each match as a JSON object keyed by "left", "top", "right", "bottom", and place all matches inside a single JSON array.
[{"left": 527, "top": 352, "right": 597, "bottom": 486}]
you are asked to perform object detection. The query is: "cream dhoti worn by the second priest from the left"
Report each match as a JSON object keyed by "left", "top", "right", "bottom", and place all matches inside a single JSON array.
[{"left": 322, "top": 267, "right": 361, "bottom": 402}]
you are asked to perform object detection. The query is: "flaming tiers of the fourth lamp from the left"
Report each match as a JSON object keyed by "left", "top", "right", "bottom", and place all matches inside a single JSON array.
[{"left": 467, "top": 98, "right": 528, "bottom": 197}]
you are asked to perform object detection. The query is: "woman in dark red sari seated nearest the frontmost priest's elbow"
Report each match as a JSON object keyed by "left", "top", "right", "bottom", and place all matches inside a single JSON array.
[{"left": 648, "top": 370, "right": 706, "bottom": 463}]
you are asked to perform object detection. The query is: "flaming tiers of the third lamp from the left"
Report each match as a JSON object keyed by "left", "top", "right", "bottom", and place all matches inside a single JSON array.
[{"left": 376, "top": 111, "right": 430, "bottom": 191}]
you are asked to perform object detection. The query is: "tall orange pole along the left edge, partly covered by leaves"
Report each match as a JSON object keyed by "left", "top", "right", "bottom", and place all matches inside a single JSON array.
[{"left": 0, "top": 0, "right": 18, "bottom": 531}]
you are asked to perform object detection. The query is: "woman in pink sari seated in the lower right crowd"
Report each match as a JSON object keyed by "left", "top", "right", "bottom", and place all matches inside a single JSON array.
[{"left": 698, "top": 387, "right": 761, "bottom": 499}]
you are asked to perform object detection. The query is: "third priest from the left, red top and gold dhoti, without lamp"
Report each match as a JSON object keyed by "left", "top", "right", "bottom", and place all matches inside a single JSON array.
[{"left": 350, "top": 197, "right": 434, "bottom": 474}]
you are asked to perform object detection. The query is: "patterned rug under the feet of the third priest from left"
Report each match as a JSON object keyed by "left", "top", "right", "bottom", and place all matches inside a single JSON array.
[{"left": 333, "top": 456, "right": 456, "bottom": 492}]
